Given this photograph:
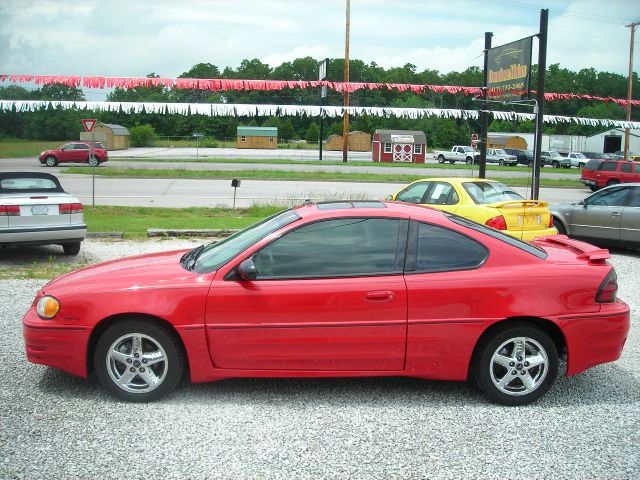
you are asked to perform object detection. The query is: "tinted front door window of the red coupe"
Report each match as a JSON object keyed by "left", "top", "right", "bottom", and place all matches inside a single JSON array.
[{"left": 253, "top": 218, "right": 407, "bottom": 280}]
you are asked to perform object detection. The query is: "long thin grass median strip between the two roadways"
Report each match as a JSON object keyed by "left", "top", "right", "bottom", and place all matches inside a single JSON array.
[{"left": 62, "top": 167, "right": 582, "bottom": 188}]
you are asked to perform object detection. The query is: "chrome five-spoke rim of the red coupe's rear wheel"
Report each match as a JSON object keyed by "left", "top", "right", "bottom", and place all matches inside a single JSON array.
[{"left": 489, "top": 337, "right": 549, "bottom": 396}]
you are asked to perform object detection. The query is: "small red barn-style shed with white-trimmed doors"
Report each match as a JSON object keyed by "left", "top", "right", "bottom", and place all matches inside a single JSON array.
[{"left": 371, "top": 130, "right": 427, "bottom": 163}]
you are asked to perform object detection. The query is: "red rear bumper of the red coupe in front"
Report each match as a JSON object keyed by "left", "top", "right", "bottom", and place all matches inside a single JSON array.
[{"left": 558, "top": 300, "right": 631, "bottom": 376}]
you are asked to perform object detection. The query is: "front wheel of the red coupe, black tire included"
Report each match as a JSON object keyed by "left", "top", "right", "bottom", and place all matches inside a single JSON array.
[{"left": 93, "top": 319, "right": 185, "bottom": 402}]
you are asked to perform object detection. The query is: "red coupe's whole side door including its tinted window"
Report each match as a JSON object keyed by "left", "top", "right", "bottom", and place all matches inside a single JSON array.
[{"left": 206, "top": 217, "right": 408, "bottom": 371}]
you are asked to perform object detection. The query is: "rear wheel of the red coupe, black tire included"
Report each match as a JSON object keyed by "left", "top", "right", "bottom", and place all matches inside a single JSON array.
[{"left": 472, "top": 322, "right": 558, "bottom": 406}]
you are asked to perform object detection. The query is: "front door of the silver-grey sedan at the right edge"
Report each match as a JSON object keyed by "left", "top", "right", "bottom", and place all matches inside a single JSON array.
[{"left": 570, "top": 185, "right": 630, "bottom": 241}]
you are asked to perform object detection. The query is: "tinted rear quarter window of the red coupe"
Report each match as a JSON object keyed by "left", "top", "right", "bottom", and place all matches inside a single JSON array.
[{"left": 414, "top": 223, "right": 489, "bottom": 272}]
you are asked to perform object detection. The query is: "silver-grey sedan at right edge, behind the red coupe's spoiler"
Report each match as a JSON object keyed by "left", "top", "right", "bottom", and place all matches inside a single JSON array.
[{"left": 549, "top": 183, "right": 640, "bottom": 248}]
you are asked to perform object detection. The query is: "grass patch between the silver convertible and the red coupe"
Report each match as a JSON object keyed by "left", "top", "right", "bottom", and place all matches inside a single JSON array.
[{"left": 84, "top": 205, "right": 285, "bottom": 239}]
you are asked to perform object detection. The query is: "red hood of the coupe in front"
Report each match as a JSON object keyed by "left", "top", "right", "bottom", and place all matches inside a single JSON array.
[{"left": 42, "top": 250, "right": 199, "bottom": 296}]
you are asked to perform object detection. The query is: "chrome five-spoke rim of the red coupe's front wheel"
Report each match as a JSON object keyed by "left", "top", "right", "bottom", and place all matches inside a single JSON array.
[{"left": 106, "top": 333, "right": 169, "bottom": 393}]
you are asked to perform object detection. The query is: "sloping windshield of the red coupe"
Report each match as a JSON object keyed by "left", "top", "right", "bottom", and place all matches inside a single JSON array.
[{"left": 192, "top": 210, "right": 300, "bottom": 273}]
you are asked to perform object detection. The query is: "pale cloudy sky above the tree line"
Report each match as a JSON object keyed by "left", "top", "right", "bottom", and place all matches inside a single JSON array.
[{"left": 0, "top": 0, "right": 640, "bottom": 99}]
